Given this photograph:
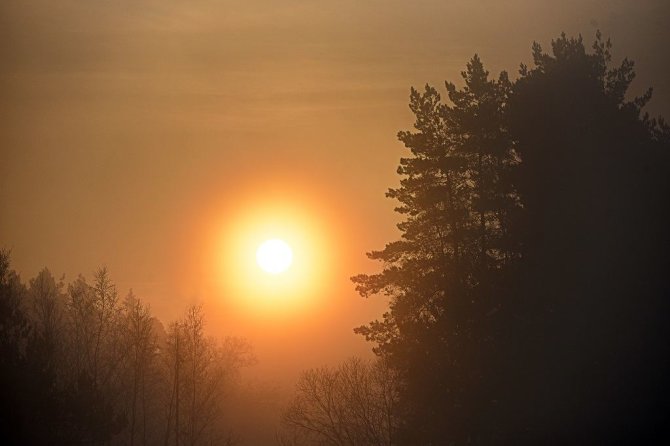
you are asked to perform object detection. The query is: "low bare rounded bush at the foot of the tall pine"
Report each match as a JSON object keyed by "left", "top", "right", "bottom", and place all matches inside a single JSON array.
[{"left": 280, "top": 358, "right": 398, "bottom": 446}]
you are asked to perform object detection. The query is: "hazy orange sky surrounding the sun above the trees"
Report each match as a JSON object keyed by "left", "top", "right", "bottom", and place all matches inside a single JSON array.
[{"left": 0, "top": 0, "right": 670, "bottom": 390}]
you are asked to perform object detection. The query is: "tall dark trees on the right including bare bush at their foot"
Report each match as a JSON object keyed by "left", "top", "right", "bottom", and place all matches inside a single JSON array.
[{"left": 283, "top": 33, "right": 670, "bottom": 445}]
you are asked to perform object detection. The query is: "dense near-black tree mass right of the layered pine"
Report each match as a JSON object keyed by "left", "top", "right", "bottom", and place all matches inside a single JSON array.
[{"left": 501, "top": 33, "right": 670, "bottom": 444}]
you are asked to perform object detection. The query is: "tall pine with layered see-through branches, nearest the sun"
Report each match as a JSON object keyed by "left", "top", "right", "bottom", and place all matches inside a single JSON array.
[{"left": 353, "top": 55, "right": 519, "bottom": 443}]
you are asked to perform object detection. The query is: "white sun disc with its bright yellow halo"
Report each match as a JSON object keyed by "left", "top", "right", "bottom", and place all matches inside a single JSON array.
[{"left": 215, "top": 197, "right": 333, "bottom": 318}]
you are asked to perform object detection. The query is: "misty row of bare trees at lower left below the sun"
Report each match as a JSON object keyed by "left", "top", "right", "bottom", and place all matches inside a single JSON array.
[{"left": 0, "top": 251, "right": 253, "bottom": 445}]
